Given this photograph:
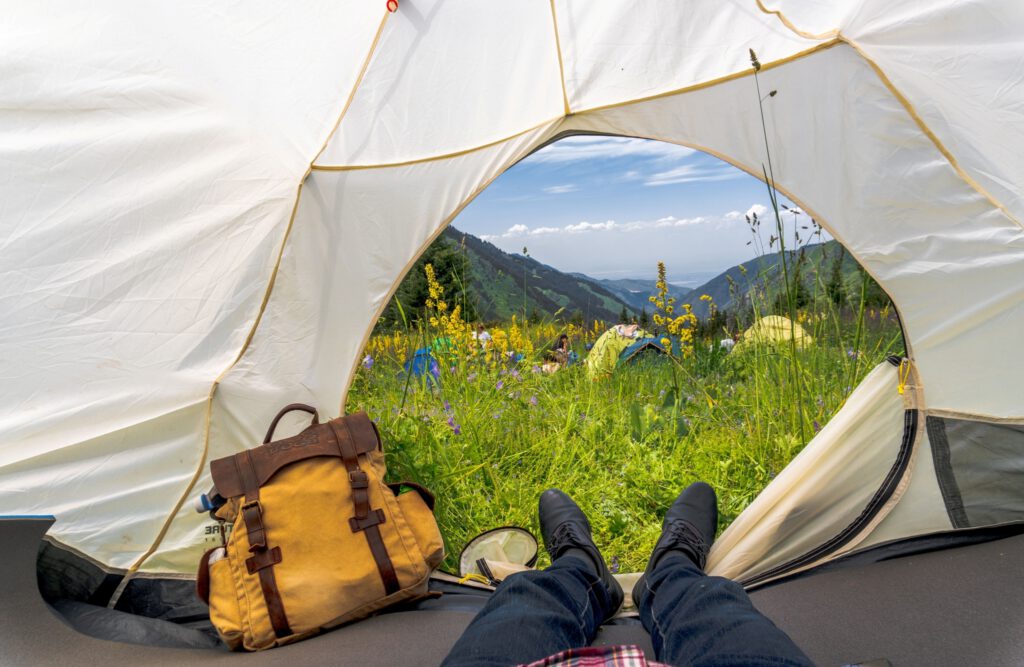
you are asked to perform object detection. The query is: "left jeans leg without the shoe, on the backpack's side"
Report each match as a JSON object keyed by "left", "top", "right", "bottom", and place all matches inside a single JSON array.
[{"left": 442, "top": 556, "right": 614, "bottom": 667}]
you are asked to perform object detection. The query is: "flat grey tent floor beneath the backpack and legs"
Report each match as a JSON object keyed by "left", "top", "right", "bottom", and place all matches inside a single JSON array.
[{"left": 0, "top": 518, "right": 1024, "bottom": 667}]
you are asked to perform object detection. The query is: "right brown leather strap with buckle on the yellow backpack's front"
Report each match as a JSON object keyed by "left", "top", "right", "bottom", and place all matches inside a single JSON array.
[{"left": 330, "top": 413, "right": 401, "bottom": 595}]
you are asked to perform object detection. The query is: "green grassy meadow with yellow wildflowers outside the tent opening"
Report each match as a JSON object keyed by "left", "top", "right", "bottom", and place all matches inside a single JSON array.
[{"left": 348, "top": 261, "right": 903, "bottom": 572}]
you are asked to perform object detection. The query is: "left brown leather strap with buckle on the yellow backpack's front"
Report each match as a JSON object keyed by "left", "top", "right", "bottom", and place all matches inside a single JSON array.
[{"left": 233, "top": 450, "right": 293, "bottom": 637}]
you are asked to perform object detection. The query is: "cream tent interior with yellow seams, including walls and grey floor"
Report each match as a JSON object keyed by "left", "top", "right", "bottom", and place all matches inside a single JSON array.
[{"left": 0, "top": 0, "right": 1024, "bottom": 665}]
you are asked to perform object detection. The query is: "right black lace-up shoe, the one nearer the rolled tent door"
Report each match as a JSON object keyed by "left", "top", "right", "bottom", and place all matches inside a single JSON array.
[{"left": 633, "top": 482, "right": 718, "bottom": 605}]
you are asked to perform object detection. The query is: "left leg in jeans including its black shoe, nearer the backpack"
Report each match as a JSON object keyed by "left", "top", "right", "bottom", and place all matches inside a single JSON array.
[{"left": 443, "top": 489, "right": 623, "bottom": 667}]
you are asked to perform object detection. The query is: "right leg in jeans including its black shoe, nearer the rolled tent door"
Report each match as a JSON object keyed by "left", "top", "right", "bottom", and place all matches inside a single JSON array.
[{"left": 633, "top": 483, "right": 813, "bottom": 667}]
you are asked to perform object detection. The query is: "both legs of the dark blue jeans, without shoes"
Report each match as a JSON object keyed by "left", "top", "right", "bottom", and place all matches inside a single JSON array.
[{"left": 443, "top": 552, "right": 814, "bottom": 667}]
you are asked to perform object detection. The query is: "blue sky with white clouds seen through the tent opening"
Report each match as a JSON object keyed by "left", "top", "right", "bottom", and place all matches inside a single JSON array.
[{"left": 454, "top": 136, "right": 807, "bottom": 286}]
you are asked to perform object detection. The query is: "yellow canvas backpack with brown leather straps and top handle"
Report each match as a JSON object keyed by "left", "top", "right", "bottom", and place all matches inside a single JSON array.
[{"left": 198, "top": 404, "right": 444, "bottom": 651}]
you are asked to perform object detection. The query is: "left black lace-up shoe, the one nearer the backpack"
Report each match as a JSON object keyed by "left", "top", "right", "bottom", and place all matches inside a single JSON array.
[{"left": 538, "top": 489, "right": 625, "bottom": 620}]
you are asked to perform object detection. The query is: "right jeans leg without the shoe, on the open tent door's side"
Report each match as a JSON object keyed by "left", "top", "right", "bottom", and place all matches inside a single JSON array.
[{"left": 634, "top": 551, "right": 814, "bottom": 666}]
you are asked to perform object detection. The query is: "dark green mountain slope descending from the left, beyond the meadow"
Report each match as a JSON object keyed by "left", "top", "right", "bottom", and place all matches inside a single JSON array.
[{"left": 442, "top": 226, "right": 634, "bottom": 323}]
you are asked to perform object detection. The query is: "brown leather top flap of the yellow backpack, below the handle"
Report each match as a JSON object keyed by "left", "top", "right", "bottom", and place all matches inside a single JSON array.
[{"left": 210, "top": 412, "right": 381, "bottom": 498}]
